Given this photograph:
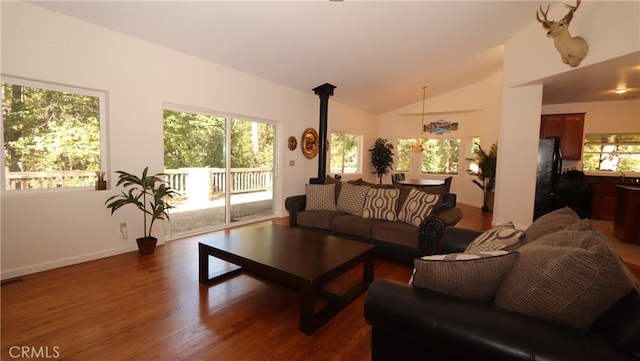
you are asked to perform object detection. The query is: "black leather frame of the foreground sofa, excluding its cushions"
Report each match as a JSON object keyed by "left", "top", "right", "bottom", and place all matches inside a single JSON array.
[{"left": 364, "top": 227, "right": 640, "bottom": 361}]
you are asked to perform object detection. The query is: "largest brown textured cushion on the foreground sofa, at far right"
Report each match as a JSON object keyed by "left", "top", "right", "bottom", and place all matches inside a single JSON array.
[{"left": 495, "top": 220, "right": 633, "bottom": 330}]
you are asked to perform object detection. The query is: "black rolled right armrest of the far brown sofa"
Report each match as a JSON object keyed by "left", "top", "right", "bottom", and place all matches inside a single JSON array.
[{"left": 419, "top": 207, "right": 462, "bottom": 256}]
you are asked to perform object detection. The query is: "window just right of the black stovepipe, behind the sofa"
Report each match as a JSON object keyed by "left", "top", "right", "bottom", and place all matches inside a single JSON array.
[{"left": 329, "top": 132, "right": 362, "bottom": 174}]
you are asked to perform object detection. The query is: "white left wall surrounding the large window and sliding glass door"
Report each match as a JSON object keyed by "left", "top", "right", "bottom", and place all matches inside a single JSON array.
[{"left": 0, "top": 1, "right": 377, "bottom": 279}]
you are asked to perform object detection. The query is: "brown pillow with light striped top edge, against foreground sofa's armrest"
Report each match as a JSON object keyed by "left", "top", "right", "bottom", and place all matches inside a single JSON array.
[{"left": 410, "top": 251, "right": 518, "bottom": 302}]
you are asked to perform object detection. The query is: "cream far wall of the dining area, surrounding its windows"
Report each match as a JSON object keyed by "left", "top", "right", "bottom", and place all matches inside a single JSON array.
[{"left": 378, "top": 72, "right": 502, "bottom": 207}]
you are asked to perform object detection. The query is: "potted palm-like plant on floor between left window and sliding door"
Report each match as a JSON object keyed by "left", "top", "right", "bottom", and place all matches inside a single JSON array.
[{"left": 105, "top": 167, "right": 176, "bottom": 254}]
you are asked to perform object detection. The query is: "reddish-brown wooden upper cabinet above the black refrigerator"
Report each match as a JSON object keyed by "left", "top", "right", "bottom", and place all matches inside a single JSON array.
[{"left": 540, "top": 113, "right": 586, "bottom": 160}]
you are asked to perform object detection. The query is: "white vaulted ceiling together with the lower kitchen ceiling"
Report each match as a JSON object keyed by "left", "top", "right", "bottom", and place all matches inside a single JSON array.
[{"left": 32, "top": 0, "right": 640, "bottom": 114}]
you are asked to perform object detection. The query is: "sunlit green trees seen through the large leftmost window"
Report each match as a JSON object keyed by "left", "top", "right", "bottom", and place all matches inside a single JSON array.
[{"left": 2, "top": 83, "right": 101, "bottom": 172}]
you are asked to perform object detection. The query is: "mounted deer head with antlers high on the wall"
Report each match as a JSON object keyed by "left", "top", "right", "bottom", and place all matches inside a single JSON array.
[{"left": 536, "top": 0, "right": 589, "bottom": 68}]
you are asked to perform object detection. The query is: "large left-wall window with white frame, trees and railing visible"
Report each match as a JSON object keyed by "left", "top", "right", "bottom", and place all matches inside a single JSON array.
[{"left": 2, "top": 77, "right": 107, "bottom": 190}]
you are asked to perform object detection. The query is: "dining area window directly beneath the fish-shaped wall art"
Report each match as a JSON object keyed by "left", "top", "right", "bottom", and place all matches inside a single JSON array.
[{"left": 421, "top": 138, "right": 460, "bottom": 174}]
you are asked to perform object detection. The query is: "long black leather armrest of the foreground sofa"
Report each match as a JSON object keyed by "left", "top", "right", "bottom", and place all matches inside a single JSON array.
[{"left": 364, "top": 279, "right": 632, "bottom": 360}]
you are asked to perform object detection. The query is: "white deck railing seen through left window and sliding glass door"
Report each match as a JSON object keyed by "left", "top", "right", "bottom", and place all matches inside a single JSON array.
[{"left": 5, "top": 168, "right": 273, "bottom": 199}]
